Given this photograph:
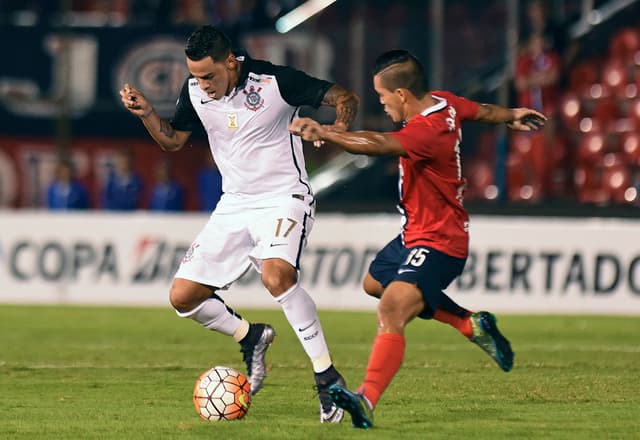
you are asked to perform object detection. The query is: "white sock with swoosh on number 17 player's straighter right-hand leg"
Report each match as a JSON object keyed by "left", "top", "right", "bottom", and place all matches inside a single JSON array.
[{"left": 275, "top": 284, "right": 331, "bottom": 373}]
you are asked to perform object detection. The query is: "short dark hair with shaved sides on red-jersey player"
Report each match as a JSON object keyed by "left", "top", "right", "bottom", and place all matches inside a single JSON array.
[{"left": 373, "top": 49, "right": 429, "bottom": 98}]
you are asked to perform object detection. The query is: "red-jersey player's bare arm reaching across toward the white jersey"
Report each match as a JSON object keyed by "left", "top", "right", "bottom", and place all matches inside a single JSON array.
[{"left": 289, "top": 118, "right": 406, "bottom": 156}]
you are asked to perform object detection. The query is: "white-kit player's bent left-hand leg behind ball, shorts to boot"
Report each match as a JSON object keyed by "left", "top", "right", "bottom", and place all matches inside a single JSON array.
[{"left": 170, "top": 213, "right": 275, "bottom": 394}]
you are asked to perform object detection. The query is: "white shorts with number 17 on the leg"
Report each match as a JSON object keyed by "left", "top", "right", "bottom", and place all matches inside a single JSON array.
[{"left": 175, "top": 194, "right": 315, "bottom": 288}]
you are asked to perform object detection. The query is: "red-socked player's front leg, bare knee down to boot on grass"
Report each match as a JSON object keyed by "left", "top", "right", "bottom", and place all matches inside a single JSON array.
[{"left": 329, "top": 281, "right": 424, "bottom": 429}]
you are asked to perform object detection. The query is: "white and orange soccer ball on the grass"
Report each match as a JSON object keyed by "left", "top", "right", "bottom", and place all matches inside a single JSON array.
[{"left": 193, "top": 366, "right": 251, "bottom": 422}]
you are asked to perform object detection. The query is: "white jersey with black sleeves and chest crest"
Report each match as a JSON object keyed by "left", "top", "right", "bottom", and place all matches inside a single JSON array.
[{"left": 171, "top": 56, "right": 332, "bottom": 201}]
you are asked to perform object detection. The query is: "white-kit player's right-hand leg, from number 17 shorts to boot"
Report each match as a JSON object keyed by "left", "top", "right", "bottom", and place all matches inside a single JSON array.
[{"left": 251, "top": 198, "right": 344, "bottom": 423}]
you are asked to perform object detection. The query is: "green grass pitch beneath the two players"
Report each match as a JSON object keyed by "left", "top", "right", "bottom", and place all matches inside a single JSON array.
[{"left": 0, "top": 305, "right": 640, "bottom": 440}]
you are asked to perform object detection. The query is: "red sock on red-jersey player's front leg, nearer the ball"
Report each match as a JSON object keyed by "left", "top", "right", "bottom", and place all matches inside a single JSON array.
[{"left": 358, "top": 333, "right": 405, "bottom": 407}]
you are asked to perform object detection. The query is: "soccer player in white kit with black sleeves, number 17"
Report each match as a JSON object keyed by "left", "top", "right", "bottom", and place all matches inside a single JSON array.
[{"left": 120, "top": 26, "right": 359, "bottom": 422}]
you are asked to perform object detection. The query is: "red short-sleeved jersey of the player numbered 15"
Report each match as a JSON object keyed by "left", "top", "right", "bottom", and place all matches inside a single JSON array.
[{"left": 390, "top": 91, "right": 478, "bottom": 258}]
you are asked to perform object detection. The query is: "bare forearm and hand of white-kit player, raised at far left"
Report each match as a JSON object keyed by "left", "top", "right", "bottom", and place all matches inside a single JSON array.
[{"left": 120, "top": 84, "right": 191, "bottom": 151}]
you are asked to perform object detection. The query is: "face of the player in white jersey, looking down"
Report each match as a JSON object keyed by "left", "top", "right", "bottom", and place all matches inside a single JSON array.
[{"left": 187, "top": 55, "right": 237, "bottom": 99}]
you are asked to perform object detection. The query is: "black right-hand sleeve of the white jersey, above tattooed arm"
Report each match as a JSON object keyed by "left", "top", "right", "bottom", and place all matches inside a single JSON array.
[{"left": 274, "top": 66, "right": 333, "bottom": 108}]
